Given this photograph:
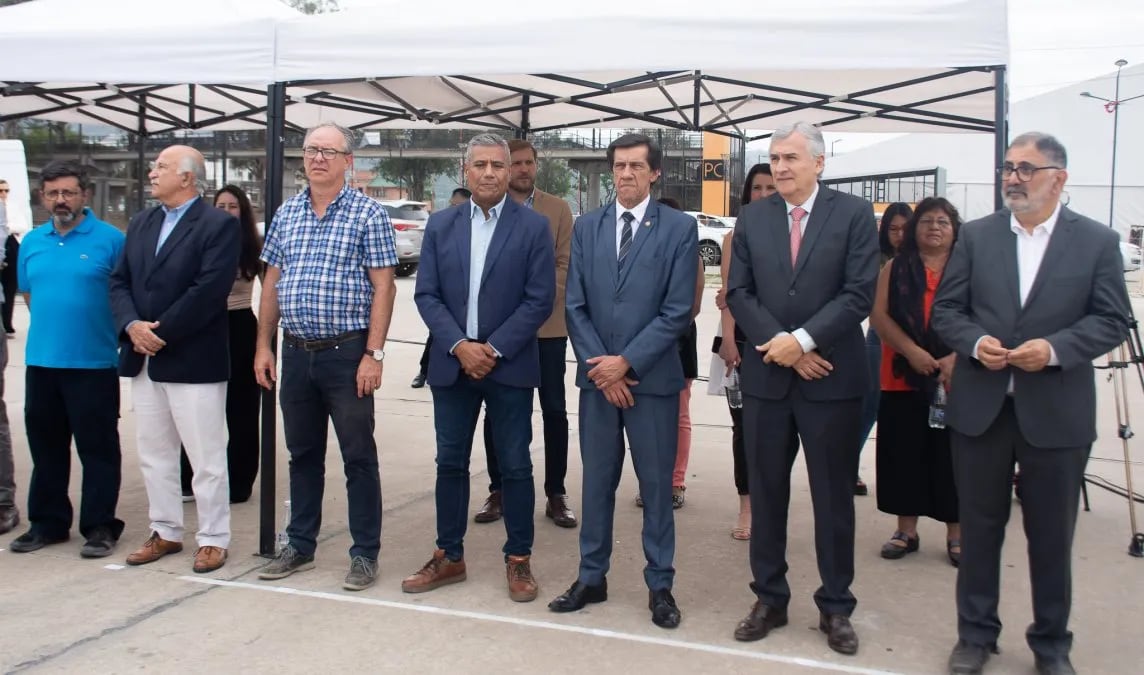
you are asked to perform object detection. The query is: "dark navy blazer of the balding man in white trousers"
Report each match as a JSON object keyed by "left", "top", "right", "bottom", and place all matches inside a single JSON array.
[{"left": 111, "top": 198, "right": 241, "bottom": 384}]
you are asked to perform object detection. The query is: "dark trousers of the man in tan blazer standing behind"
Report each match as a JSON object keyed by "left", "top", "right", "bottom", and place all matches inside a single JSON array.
[{"left": 484, "top": 338, "right": 569, "bottom": 497}]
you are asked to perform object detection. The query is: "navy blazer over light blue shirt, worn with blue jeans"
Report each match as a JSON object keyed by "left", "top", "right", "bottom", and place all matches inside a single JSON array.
[{"left": 413, "top": 197, "right": 556, "bottom": 387}]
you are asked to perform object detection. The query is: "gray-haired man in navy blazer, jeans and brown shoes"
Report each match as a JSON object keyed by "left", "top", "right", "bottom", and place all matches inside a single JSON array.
[{"left": 402, "top": 134, "right": 555, "bottom": 602}]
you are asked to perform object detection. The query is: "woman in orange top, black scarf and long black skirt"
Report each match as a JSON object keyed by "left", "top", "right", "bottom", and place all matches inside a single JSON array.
[{"left": 871, "top": 197, "right": 961, "bottom": 566}]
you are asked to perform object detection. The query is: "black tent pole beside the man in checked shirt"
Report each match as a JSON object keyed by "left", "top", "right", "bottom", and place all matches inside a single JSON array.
[{"left": 259, "top": 82, "right": 286, "bottom": 557}]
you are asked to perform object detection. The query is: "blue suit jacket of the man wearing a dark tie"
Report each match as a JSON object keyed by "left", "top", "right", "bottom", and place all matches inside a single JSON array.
[{"left": 565, "top": 201, "right": 699, "bottom": 396}]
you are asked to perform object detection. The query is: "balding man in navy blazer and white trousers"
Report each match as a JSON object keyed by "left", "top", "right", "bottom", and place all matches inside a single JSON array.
[{"left": 111, "top": 145, "right": 241, "bottom": 572}]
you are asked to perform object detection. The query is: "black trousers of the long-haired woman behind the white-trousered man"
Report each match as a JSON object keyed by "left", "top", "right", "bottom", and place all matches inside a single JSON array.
[{"left": 181, "top": 309, "right": 262, "bottom": 502}]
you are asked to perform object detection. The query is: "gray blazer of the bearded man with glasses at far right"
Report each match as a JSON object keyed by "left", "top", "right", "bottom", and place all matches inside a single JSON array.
[{"left": 930, "top": 207, "right": 1131, "bottom": 447}]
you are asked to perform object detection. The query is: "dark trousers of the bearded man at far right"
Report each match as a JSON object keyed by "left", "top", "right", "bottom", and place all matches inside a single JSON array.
[{"left": 952, "top": 399, "right": 1091, "bottom": 658}]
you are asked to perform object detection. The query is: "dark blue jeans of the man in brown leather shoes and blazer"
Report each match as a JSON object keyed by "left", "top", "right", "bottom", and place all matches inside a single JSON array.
[{"left": 432, "top": 373, "right": 537, "bottom": 561}]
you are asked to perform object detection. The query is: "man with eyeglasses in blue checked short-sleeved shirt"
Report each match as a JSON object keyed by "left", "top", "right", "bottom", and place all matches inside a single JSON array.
[{"left": 254, "top": 122, "right": 397, "bottom": 590}]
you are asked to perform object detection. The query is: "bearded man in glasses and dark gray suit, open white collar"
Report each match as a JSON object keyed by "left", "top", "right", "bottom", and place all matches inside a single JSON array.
[{"left": 931, "top": 133, "right": 1131, "bottom": 674}]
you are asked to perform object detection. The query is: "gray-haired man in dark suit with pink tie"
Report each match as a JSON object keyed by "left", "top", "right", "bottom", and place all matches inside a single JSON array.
[{"left": 726, "top": 122, "right": 877, "bottom": 654}]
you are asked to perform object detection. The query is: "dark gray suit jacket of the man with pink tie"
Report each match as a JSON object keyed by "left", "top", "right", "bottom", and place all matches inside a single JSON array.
[{"left": 726, "top": 184, "right": 879, "bottom": 400}]
